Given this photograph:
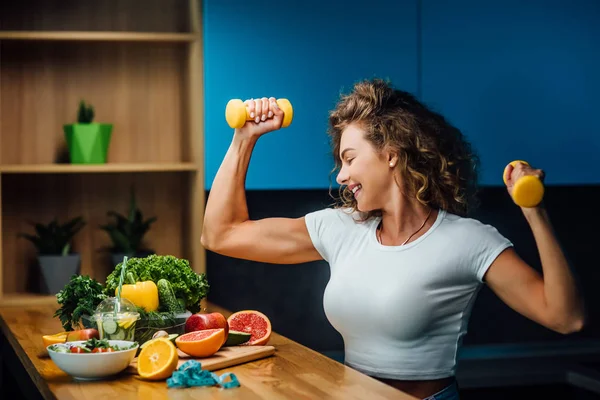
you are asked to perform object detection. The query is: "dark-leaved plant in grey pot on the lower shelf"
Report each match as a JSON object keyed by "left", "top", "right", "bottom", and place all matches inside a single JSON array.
[{"left": 19, "top": 217, "right": 85, "bottom": 294}]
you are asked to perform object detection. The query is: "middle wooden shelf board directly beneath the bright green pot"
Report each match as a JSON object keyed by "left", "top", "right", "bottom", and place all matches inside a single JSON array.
[{"left": 0, "top": 163, "right": 198, "bottom": 174}]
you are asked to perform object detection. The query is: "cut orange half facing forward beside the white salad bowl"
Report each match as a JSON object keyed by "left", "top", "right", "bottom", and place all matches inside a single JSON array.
[{"left": 137, "top": 340, "right": 179, "bottom": 380}]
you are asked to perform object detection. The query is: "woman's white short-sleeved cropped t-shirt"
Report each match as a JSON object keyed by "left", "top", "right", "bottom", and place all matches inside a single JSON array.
[{"left": 305, "top": 208, "right": 512, "bottom": 380}]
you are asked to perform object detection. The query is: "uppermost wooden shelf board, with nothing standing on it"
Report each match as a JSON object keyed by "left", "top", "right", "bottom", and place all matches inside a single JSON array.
[{"left": 0, "top": 31, "right": 199, "bottom": 43}]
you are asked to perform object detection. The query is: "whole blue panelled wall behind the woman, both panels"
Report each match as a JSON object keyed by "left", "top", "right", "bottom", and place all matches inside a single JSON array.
[{"left": 203, "top": 0, "right": 600, "bottom": 189}]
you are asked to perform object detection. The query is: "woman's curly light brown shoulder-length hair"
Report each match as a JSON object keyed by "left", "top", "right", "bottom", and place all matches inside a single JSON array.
[{"left": 328, "top": 79, "right": 479, "bottom": 219}]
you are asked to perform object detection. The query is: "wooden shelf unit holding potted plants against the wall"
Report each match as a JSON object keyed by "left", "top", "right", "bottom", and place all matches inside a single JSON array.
[{"left": 0, "top": 0, "right": 206, "bottom": 305}]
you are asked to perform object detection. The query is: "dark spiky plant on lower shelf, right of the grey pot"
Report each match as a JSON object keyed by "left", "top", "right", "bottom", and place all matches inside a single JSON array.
[{"left": 100, "top": 188, "right": 156, "bottom": 266}]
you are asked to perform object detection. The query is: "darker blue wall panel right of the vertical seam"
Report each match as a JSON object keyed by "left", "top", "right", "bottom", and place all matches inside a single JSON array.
[{"left": 421, "top": 0, "right": 600, "bottom": 184}]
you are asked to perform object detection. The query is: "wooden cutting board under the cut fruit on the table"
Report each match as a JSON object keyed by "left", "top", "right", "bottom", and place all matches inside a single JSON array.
[{"left": 126, "top": 346, "right": 275, "bottom": 374}]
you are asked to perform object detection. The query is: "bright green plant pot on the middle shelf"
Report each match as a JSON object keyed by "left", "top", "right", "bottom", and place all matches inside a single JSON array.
[{"left": 63, "top": 123, "right": 113, "bottom": 164}]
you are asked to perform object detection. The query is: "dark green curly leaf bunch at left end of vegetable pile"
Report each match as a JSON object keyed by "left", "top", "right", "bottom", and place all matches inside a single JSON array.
[{"left": 54, "top": 275, "right": 107, "bottom": 331}]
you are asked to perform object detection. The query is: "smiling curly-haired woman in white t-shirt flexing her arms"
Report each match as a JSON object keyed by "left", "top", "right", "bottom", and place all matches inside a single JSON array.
[{"left": 202, "top": 79, "right": 584, "bottom": 399}]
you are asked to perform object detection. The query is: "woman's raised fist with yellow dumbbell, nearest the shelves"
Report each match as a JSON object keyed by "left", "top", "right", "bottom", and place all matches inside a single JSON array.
[{"left": 225, "top": 97, "right": 294, "bottom": 129}]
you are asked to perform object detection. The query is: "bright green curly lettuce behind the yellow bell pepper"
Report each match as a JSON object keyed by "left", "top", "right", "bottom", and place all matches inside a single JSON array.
[{"left": 104, "top": 254, "right": 210, "bottom": 313}]
